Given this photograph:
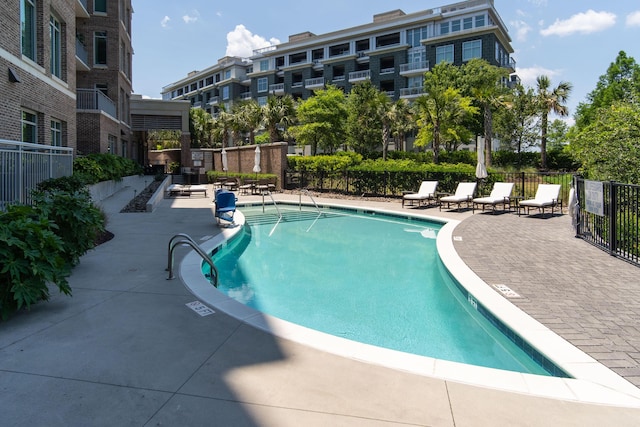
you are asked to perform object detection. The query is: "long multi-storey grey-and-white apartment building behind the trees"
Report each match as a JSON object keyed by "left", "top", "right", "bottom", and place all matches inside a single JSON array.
[{"left": 162, "top": 0, "right": 515, "bottom": 114}]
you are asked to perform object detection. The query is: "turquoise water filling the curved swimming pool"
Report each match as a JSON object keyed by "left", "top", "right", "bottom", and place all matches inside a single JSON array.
[{"left": 209, "top": 206, "right": 549, "bottom": 375}]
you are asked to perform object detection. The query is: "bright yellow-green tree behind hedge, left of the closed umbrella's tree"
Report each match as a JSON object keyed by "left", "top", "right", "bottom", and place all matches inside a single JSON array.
[{"left": 415, "top": 62, "right": 478, "bottom": 163}]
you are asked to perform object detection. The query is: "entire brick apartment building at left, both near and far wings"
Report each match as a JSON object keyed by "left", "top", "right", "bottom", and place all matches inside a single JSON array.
[{"left": 0, "top": 0, "right": 133, "bottom": 157}]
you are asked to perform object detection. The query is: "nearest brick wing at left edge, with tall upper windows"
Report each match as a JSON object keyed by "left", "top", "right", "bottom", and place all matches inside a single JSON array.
[{"left": 0, "top": 0, "right": 80, "bottom": 148}]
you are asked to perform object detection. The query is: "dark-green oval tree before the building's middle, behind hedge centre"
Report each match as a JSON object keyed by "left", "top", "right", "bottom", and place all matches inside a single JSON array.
[{"left": 347, "top": 80, "right": 388, "bottom": 155}]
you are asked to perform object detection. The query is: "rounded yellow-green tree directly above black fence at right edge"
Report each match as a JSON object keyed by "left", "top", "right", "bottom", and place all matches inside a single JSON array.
[{"left": 570, "top": 103, "right": 640, "bottom": 184}]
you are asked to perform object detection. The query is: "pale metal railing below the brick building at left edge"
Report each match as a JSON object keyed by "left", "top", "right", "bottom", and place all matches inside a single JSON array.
[{"left": 0, "top": 140, "right": 73, "bottom": 211}]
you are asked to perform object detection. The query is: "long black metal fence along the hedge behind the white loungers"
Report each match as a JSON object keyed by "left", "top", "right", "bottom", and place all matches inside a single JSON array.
[{"left": 284, "top": 170, "right": 573, "bottom": 206}]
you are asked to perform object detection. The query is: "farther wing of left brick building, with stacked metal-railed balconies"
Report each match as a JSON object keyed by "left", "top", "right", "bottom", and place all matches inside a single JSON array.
[{"left": 76, "top": 0, "right": 137, "bottom": 158}]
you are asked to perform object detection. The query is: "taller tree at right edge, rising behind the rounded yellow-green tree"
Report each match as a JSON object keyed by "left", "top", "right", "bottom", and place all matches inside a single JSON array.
[{"left": 575, "top": 51, "right": 640, "bottom": 129}]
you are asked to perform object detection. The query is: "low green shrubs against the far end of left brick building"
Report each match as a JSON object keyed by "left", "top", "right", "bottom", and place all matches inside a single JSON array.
[{"left": 73, "top": 153, "right": 143, "bottom": 184}]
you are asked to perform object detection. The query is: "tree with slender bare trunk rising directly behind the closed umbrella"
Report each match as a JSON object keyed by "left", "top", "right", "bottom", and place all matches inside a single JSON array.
[{"left": 462, "top": 58, "right": 509, "bottom": 166}]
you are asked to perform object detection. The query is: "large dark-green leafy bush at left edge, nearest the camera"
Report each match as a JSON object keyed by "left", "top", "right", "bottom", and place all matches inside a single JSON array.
[{"left": 0, "top": 206, "right": 71, "bottom": 320}]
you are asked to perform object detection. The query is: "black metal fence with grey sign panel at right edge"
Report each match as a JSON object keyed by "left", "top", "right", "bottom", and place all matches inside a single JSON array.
[{"left": 575, "top": 177, "right": 640, "bottom": 266}]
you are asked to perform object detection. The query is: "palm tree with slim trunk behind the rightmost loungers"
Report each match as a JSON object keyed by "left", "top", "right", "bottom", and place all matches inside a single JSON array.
[{"left": 536, "top": 75, "right": 573, "bottom": 170}]
